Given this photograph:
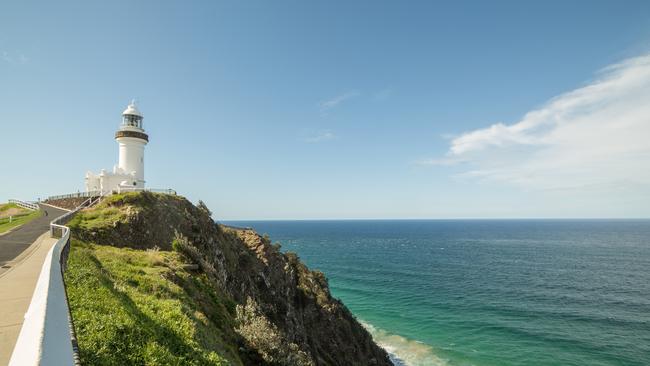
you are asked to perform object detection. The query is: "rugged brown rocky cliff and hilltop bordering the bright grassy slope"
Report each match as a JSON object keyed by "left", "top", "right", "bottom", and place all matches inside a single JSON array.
[{"left": 71, "top": 192, "right": 391, "bottom": 366}]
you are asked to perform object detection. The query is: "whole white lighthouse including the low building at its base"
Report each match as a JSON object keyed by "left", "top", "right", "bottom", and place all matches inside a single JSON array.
[{"left": 85, "top": 101, "right": 149, "bottom": 195}]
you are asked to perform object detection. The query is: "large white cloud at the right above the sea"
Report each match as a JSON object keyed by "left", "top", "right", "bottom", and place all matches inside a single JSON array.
[{"left": 429, "top": 55, "right": 650, "bottom": 190}]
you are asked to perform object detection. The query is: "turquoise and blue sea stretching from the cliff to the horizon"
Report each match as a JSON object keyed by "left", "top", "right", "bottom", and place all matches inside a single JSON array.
[{"left": 224, "top": 220, "right": 650, "bottom": 365}]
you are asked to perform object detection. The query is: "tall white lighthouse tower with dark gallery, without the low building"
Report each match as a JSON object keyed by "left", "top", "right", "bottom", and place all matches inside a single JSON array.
[{"left": 115, "top": 101, "right": 149, "bottom": 188}]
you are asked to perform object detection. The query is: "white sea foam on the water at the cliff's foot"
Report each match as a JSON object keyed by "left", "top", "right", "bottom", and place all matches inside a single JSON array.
[{"left": 360, "top": 320, "right": 447, "bottom": 366}]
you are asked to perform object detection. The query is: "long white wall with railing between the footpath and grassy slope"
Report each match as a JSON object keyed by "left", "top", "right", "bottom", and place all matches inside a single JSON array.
[{"left": 9, "top": 198, "right": 97, "bottom": 366}]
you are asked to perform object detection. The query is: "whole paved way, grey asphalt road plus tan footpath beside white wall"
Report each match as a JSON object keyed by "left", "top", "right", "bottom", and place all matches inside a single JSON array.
[{"left": 0, "top": 205, "right": 65, "bottom": 366}]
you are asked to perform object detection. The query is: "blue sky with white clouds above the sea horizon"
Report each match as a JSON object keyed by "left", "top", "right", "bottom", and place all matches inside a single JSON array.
[{"left": 0, "top": 0, "right": 650, "bottom": 220}]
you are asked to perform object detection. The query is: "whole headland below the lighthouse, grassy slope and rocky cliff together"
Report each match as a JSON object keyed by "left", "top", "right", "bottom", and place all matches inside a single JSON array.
[{"left": 66, "top": 193, "right": 390, "bottom": 365}]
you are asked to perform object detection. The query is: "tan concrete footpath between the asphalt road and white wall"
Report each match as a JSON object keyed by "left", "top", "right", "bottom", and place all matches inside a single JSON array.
[{"left": 0, "top": 231, "right": 57, "bottom": 365}]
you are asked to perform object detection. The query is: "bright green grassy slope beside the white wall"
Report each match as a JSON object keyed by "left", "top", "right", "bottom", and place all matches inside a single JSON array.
[{"left": 65, "top": 240, "right": 241, "bottom": 365}]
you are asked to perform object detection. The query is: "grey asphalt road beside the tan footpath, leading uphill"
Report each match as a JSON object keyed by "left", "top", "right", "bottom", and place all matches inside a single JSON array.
[{"left": 0, "top": 205, "right": 66, "bottom": 276}]
